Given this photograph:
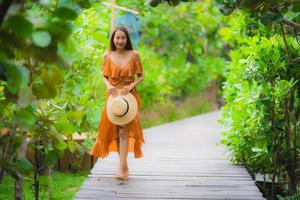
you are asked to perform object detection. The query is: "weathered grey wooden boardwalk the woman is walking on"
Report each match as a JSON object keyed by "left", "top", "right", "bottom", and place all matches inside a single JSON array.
[{"left": 75, "top": 111, "right": 264, "bottom": 200}]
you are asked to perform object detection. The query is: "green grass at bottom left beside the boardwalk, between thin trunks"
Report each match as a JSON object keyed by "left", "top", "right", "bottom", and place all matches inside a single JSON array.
[{"left": 0, "top": 171, "right": 89, "bottom": 200}]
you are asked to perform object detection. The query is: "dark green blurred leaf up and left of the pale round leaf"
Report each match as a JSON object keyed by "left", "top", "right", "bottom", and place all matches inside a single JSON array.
[{"left": 6, "top": 15, "right": 33, "bottom": 38}]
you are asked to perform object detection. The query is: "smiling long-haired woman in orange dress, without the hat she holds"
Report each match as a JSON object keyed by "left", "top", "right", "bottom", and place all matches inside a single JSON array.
[{"left": 90, "top": 26, "right": 145, "bottom": 180}]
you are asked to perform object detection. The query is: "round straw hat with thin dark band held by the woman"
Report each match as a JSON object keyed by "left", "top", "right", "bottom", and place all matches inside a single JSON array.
[{"left": 106, "top": 92, "right": 138, "bottom": 125}]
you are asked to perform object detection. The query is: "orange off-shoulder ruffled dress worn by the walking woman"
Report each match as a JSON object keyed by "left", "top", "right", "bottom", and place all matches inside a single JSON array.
[{"left": 90, "top": 51, "right": 145, "bottom": 158}]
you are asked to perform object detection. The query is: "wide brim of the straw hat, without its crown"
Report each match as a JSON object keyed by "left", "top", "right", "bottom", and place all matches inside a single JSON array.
[{"left": 106, "top": 92, "right": 138, "bottom": 125}]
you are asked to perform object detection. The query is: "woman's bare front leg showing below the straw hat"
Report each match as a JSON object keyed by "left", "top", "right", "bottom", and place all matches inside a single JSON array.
[{"left": 118, "top": 127, "right": 129, "bottom": 175}]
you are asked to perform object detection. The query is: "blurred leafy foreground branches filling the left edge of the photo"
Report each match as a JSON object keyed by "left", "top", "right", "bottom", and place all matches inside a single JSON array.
[{"left": 0, "top": 1, "right": 94, "bottom": 197}]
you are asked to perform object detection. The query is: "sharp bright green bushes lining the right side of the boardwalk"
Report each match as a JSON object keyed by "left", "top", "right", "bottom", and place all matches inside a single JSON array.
[{"left": 220, "top": 5, "right": 300, "bottom": 198}]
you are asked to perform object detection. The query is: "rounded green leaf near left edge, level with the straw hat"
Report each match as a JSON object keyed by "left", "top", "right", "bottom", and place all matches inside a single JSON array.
[{"left": 15, "top": 106, "right": 37, "bottom": 126}]
